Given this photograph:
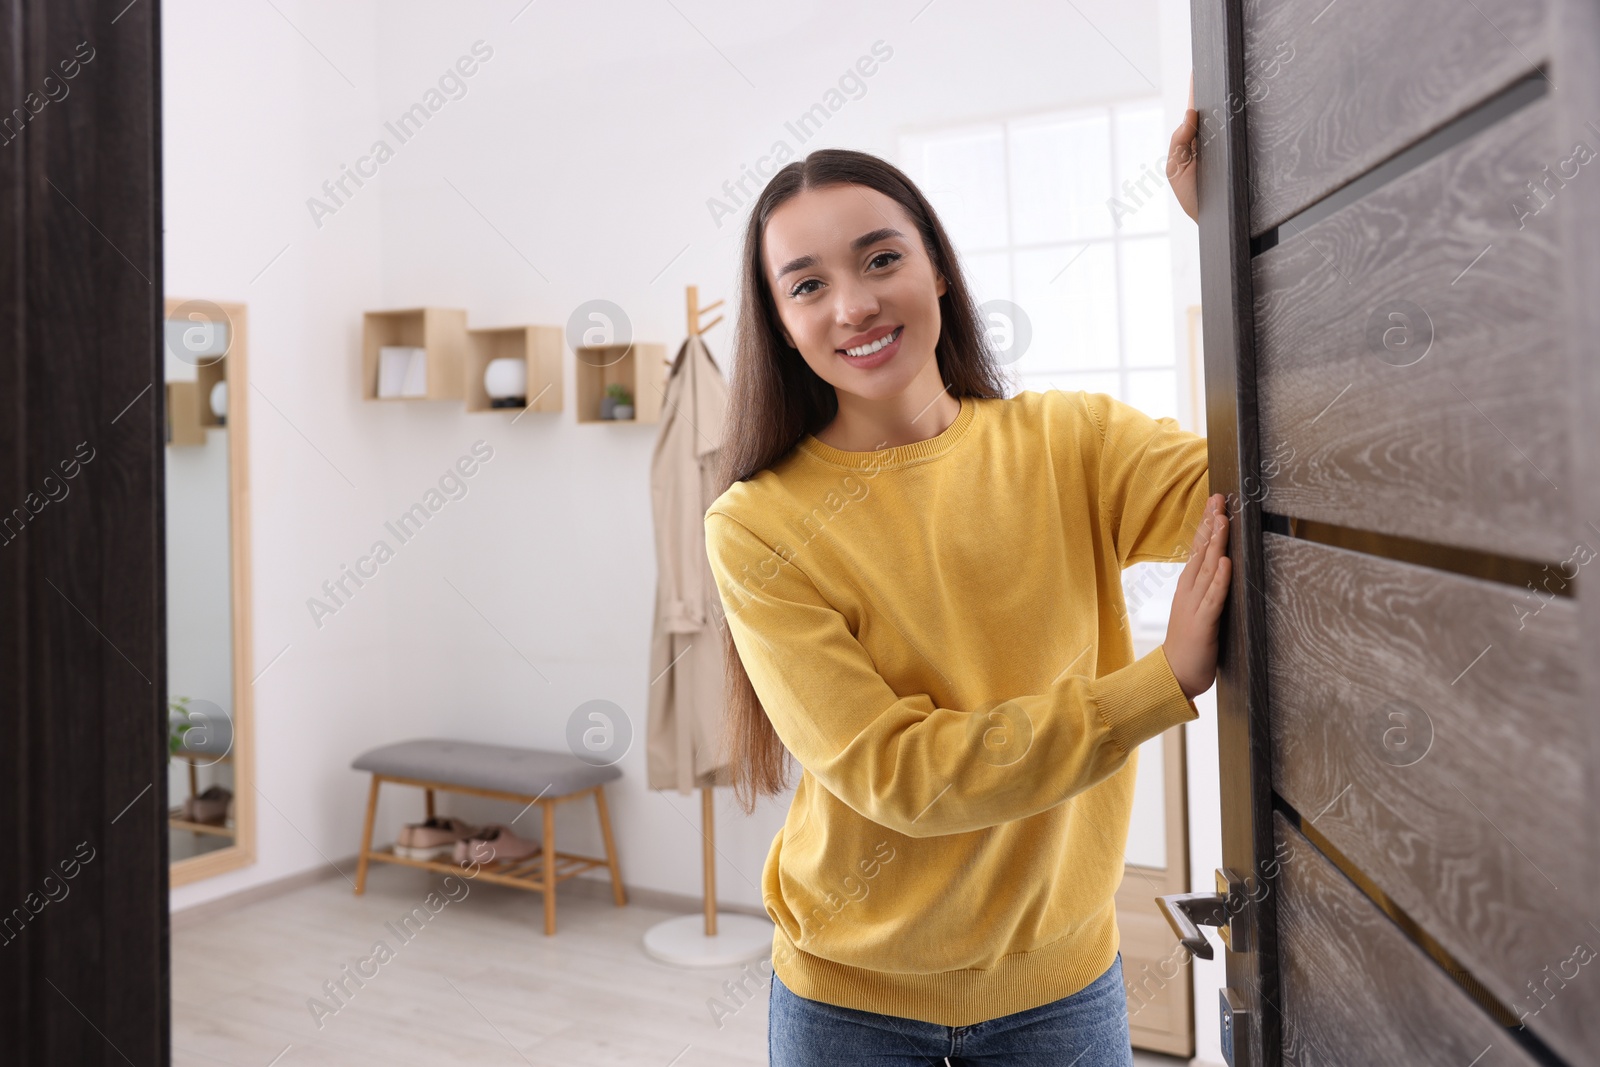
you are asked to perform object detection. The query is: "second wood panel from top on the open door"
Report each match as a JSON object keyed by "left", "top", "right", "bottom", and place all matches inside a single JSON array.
[{"left": 1246, "top": 96, "right": 1574, "bottom": 561}]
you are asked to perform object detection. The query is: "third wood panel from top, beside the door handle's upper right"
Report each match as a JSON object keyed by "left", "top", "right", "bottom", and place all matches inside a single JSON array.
[{"left": 1262, "top": 533, "right": 1600, "bottom": 1062}]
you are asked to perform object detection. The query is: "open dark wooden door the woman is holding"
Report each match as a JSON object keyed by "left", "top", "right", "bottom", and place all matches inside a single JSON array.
[{"left": 1174, "top": 0, "right": 1600, "bottom": 1067}]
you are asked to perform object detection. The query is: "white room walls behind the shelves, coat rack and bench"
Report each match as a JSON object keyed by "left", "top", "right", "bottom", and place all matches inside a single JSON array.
[{"left": 163, "top": 0, "right": 1216, "bottom": 1059}]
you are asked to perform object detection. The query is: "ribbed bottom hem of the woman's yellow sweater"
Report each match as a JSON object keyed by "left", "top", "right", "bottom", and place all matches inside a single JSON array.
[{"left": 773, "top": 901, "right": 1122, "bottom": 1027}]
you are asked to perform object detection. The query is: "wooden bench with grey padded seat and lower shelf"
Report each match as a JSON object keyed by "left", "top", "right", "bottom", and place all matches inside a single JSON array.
[{"left": 350, "top": 737, "right": 627, "bottom": 934}]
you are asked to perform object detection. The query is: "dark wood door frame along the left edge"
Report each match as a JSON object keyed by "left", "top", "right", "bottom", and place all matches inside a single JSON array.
[{"left": 0, "top": 0, "right": 171, "bottom": 1067}]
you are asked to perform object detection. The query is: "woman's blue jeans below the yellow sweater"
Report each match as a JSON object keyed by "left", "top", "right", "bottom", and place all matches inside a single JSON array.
[{"left": 766, "top": 952, "right": 1133, "bottom": 1067}]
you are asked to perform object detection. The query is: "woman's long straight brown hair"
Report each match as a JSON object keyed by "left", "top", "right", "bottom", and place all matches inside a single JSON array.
[{"left": 718, "top": 149, "right": 1008, "bottom": 814}]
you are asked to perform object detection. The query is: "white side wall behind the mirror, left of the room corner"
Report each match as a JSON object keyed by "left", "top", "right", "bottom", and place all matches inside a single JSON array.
[{"left": 162, "top": 0, "right": 390, "bottom": 909}]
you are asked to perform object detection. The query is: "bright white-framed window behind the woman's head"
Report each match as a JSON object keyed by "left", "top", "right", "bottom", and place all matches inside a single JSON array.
[{"left": 901, "top": 99, "right": 1181, "bottom": 418}]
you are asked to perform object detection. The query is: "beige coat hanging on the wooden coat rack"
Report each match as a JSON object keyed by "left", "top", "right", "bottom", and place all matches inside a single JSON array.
[{"left": 646, "top": 334, "right": 733, "bottom": 793}]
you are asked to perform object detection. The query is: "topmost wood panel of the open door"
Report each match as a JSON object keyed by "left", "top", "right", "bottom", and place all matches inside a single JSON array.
[{"left": 1243, "top": 0, "right": 1550, "bottom": 235}]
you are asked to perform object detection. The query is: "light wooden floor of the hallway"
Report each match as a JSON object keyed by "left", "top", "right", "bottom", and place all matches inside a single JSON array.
[{"left": 171, "top": 864, "right": 1182, "bottom": 1067}]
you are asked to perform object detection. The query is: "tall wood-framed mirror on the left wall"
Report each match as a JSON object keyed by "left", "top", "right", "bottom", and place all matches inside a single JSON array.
[{"left": 163, "top": 298, "right": 256, "bottom": 886}]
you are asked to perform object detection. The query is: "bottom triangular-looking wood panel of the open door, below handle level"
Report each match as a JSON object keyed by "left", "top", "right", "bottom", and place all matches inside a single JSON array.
[{"left": 1272, "top": 813, "right": 1536, "bottom": 1067}]
